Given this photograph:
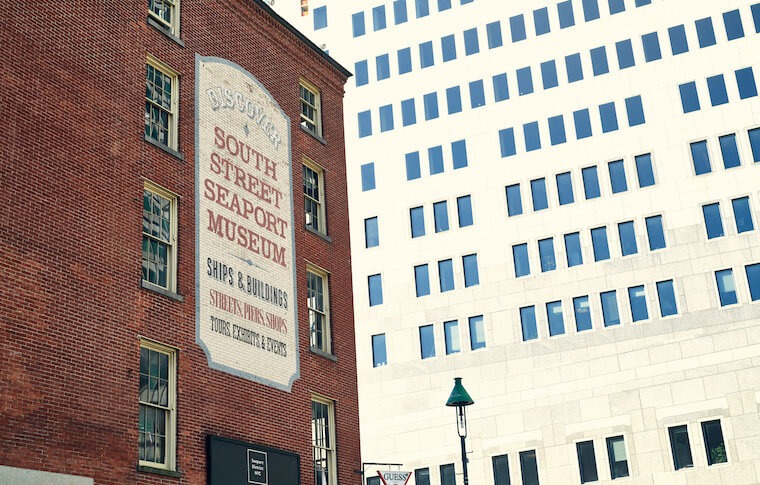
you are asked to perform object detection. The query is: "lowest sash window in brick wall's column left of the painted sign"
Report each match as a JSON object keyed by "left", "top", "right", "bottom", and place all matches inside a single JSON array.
[{"left": 138, "top": 340, "right": 177, "bottom": 470}]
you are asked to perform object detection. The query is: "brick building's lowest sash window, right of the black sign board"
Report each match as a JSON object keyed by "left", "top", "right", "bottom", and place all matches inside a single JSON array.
[{"left": 311, "top": 396, "right": 338, "bottom": 485}]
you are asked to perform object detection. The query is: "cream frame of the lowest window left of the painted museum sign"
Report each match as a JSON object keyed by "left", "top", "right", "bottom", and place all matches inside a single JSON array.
[{"left": 138, "top": 338, "right": 178, "bottom": 470}]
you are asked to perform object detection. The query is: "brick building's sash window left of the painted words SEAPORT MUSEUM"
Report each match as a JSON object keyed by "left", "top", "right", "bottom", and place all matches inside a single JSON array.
[{"left": 142, "top": 182, "right": 177, "bottom": 293}]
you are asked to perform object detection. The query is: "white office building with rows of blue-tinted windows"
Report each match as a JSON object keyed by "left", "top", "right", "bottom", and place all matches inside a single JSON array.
[{"left": 274, "top": 0, "right": 760, "bottom": 485}]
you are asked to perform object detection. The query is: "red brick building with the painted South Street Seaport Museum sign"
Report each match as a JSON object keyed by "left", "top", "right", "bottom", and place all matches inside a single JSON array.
[{"left": 0, "top": 0, "right": 361, "bottom": 485}]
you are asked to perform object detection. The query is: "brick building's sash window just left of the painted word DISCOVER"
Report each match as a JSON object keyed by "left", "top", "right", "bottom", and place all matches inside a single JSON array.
[{"left": 145, "top": 56, "right": 179, "bottom": 150}]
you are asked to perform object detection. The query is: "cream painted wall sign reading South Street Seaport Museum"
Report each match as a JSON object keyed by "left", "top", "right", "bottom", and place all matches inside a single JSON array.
[{"left": 195, "top": 56, "right": 299, "bottom": 391}]
